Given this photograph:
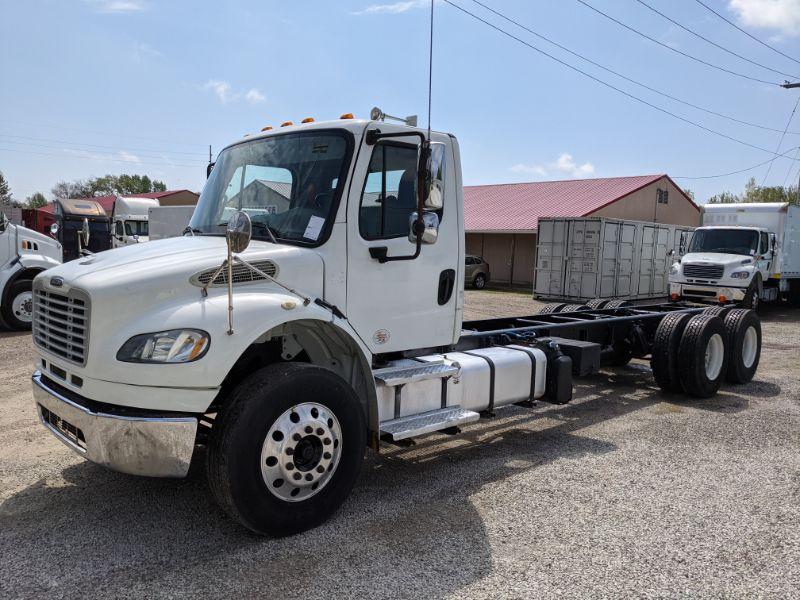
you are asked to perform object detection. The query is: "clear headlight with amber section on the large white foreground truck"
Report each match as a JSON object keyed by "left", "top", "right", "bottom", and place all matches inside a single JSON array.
[{"left": 117, "top": 329, "right": 211, "bottom": 363}]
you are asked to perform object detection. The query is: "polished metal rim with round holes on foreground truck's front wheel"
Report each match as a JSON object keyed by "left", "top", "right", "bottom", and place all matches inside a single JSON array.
[{"left": 261, "top": 402, "right": 342, "bottom": 502}]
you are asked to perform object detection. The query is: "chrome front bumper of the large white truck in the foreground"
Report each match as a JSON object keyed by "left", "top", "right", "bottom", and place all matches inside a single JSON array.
[{"left": 31, "top": 371, "right": 197, "bottom": 477}]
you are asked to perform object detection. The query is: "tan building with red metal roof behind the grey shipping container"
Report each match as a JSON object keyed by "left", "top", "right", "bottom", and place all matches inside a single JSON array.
[{"left": 464, "top": 175, "right": 700, "bottom": 285}]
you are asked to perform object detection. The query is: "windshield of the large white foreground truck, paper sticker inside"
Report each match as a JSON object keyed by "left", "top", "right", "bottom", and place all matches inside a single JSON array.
[{"left": 190, "top": 131, "right": 351, "bottom": 245}]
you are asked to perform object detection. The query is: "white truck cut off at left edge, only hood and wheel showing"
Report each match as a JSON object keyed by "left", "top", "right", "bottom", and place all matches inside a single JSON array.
[{"left": 0, "top": 213, "right": 61, "bottom": 330}]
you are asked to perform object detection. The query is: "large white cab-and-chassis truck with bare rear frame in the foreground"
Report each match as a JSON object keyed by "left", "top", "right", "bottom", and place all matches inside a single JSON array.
[{"left": 32, "top": 115, "right": 761, "bottom": 536}]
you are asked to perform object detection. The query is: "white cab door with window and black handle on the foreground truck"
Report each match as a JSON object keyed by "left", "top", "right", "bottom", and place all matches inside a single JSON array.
[{"left": 347, "top": 134, "right": 464, "bottom": 354}]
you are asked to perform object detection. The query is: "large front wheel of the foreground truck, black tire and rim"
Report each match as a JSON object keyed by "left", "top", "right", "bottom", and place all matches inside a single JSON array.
[{"left": 206, "top": 363, "right": 366, "bottom": 537}]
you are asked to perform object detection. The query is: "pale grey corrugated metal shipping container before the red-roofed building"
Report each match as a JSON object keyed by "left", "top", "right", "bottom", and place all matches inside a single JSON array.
[{"left": 533, "top": 217, "right": 694, "bottom": 301}]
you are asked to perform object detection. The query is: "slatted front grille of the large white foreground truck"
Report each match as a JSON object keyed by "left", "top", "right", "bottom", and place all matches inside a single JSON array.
[{"left": 33, "top": 285, "right": 89, "bottom": 365}]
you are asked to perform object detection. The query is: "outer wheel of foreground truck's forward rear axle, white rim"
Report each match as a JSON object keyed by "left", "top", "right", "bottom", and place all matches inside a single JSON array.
[{"left": 678, "top": 313, "right": 728, "bottom": 398}]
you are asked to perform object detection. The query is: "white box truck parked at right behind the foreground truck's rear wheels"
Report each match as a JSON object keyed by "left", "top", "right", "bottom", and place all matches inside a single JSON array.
[{"left": 669, "top": 202, "right": 800, "bottom": 309}]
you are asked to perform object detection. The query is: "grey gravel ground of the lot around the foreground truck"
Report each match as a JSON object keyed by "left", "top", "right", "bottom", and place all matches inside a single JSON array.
[{"left": 0, "top": 291, "right": 800, "bottom": 599}]
